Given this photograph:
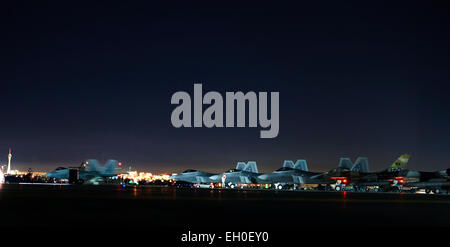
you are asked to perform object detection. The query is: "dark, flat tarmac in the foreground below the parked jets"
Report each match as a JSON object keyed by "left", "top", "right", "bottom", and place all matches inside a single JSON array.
[{"left": 0, "top": 184, "right": 450, "bottom": 229}]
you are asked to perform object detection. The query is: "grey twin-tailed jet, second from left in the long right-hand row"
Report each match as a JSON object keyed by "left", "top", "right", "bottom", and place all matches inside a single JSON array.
[{"left": 210, "top": 161, "right": 260, "bottom": 188}]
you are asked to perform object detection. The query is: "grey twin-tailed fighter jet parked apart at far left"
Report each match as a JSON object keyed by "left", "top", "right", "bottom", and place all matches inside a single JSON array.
[{"left": 45, "top": 159, "right": 121, "bottom": 183}]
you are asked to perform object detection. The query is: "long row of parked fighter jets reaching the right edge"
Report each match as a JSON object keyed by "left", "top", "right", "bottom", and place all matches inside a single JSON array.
[{"left": 171, "top": 154, "right": 450, "bottom": 193}]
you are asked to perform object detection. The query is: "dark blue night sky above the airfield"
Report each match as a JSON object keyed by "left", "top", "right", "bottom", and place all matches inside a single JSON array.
[{"left": 0, "top": 1, "right": 450, "bottom": 172}]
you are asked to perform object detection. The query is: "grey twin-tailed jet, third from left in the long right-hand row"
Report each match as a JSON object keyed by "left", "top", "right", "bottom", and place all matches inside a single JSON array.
[{"left": 258, "top": 160, "right": 319, "bottom": 189}]
